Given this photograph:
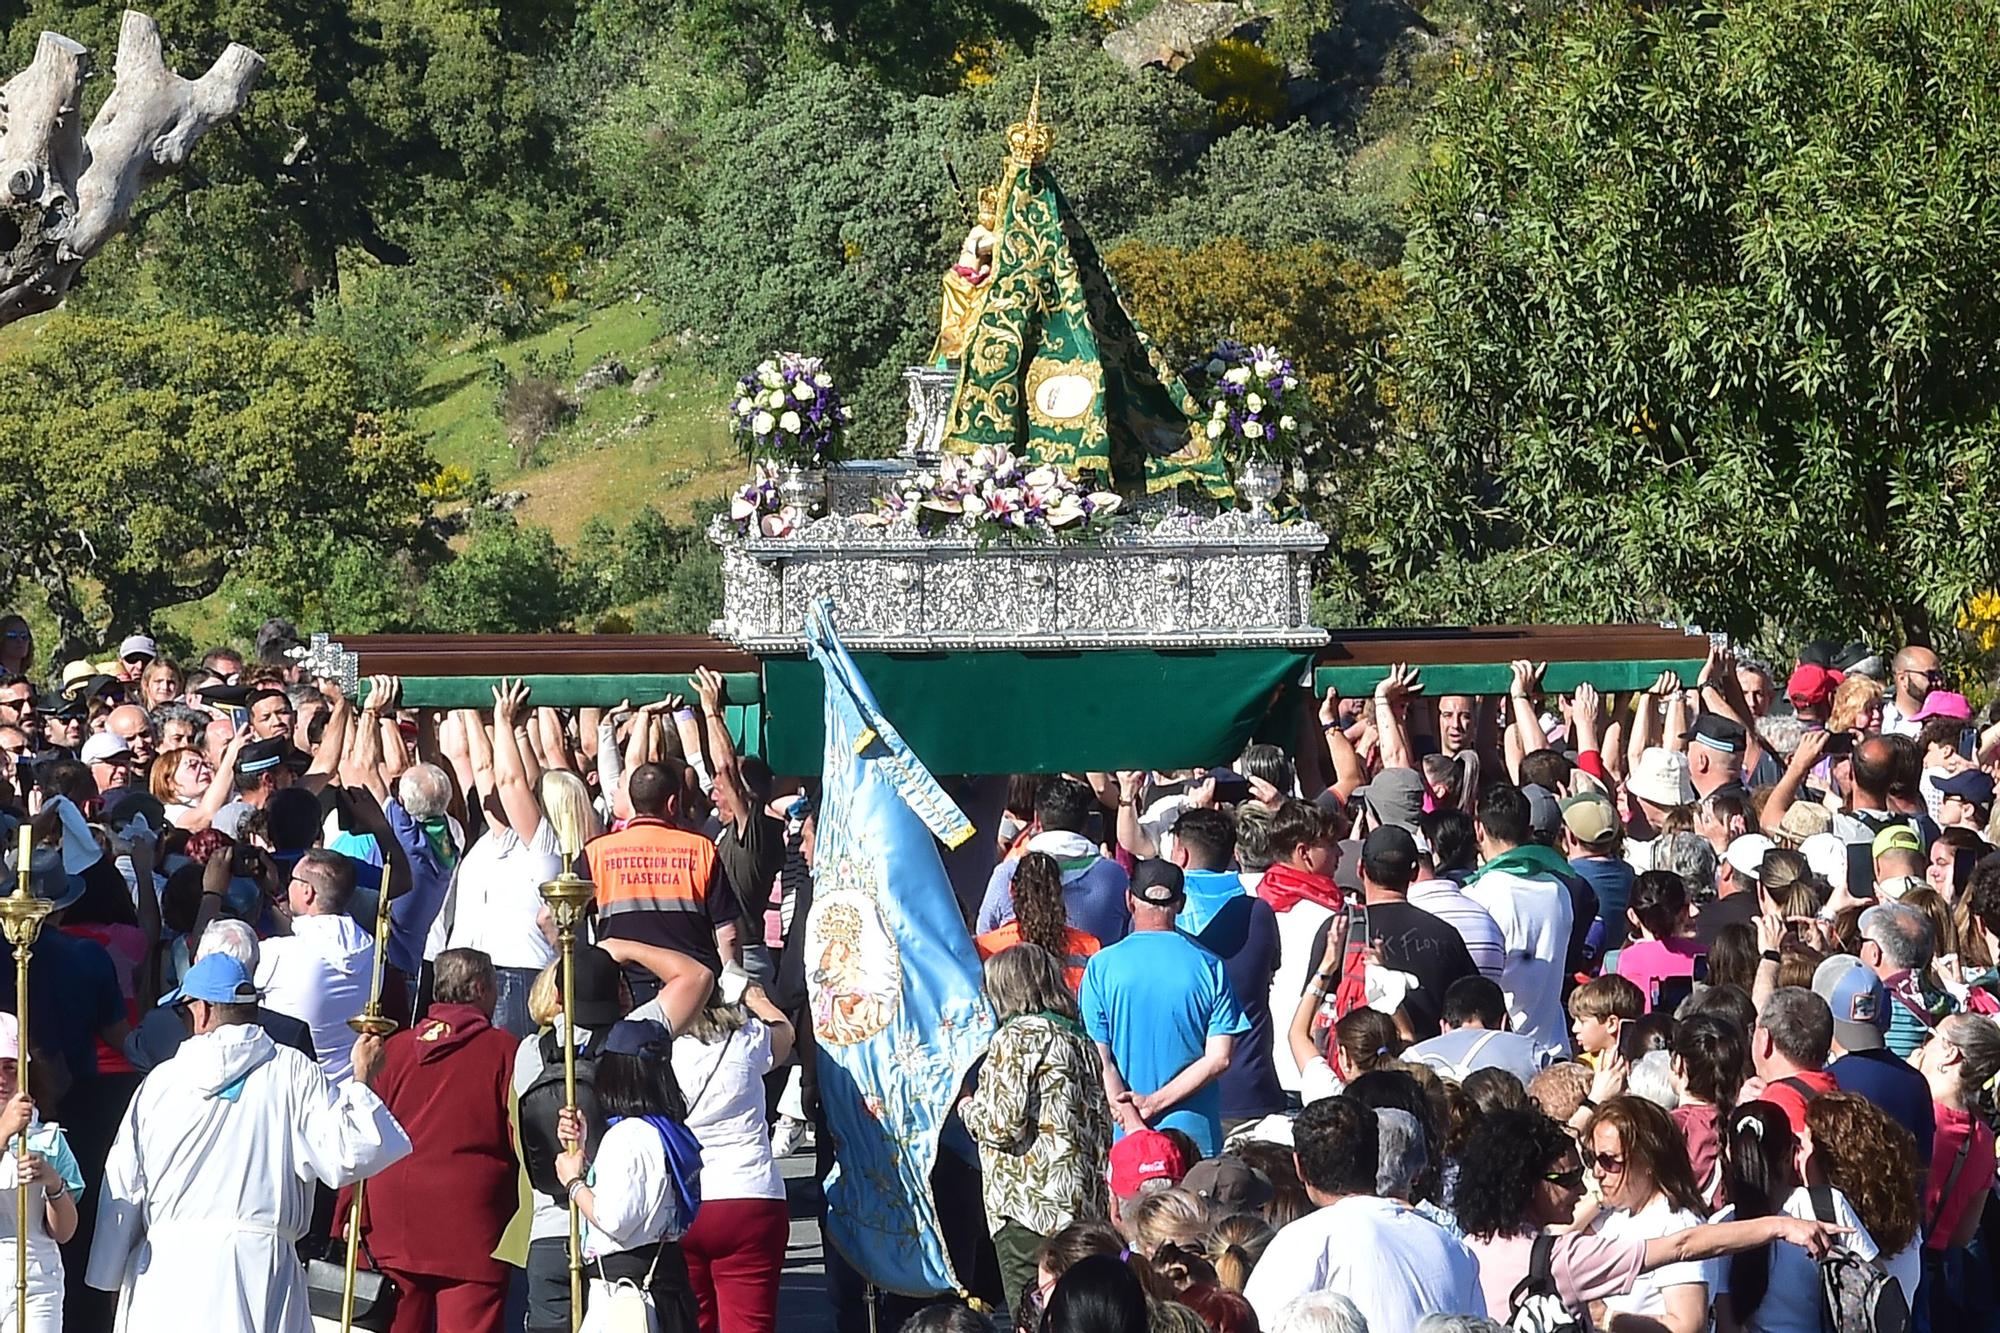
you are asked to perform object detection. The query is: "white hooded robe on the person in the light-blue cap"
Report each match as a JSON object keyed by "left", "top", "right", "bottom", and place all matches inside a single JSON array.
[{"left": 84, "top": 1025, "right": 410, "bottom": 1333}]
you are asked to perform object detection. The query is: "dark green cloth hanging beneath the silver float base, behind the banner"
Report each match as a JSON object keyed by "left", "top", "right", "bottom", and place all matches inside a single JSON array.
[{"left": 764, "top": 648, "right": 1312, "bottom": 773}]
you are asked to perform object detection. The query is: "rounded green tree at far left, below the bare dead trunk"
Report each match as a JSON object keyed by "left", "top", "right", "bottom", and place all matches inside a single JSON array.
[{"left": 0, "top": 314, "right": 436, "bottom": 652}]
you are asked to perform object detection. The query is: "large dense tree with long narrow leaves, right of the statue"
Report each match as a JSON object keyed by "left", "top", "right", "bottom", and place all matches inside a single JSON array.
[{"left": 1376, "top": 0, "right": 2000, "bottom": 638}]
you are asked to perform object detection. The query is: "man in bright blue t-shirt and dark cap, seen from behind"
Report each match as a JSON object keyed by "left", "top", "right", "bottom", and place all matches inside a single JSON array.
[{"left": 1078, "top": 861, "right": 1250, "bottom": 1157}]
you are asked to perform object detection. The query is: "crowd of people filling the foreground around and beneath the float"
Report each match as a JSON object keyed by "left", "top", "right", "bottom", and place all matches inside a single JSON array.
[{"left": 0, "top": 618, "right": 2000, "bottom": 1333}]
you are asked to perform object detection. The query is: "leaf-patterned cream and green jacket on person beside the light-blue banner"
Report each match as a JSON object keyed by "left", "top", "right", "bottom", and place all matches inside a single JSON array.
[{"left": 960, "top": 1013, "right": 1112, "bottom": 1235}]
